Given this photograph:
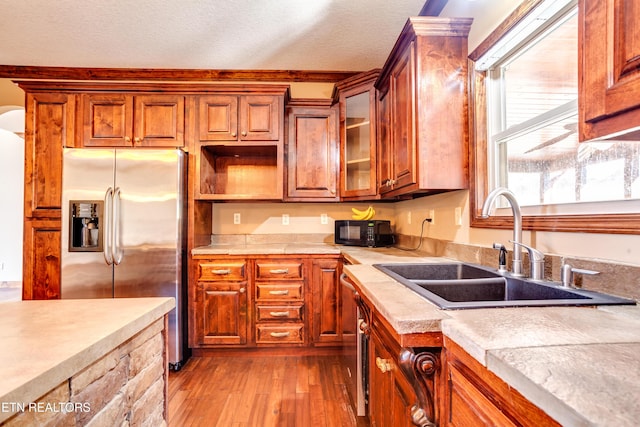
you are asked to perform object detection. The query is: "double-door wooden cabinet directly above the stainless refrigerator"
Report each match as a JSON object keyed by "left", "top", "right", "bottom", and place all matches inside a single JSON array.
[{"left": 80, "top": 93, "right": 185, "bottom": 148}]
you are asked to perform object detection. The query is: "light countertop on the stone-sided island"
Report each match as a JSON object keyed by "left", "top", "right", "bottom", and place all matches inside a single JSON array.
[{"left": 0, "top": 298, "right": 175, "bottom": 423}]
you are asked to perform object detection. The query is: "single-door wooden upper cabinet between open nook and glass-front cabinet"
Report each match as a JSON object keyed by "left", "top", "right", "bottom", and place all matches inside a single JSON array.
[{"left": 285, "top": 100, "right": 339, "bottom": 202}]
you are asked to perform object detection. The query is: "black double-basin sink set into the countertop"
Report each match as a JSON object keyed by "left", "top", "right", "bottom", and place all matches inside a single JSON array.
[{"left": 374, "top": 263, "right": 635, "bottom": 310}]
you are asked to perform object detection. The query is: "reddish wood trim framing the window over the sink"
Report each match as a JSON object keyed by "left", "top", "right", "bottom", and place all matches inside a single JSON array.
[{"left": 469, "top": 6, "right": 640, "bottom": 235}]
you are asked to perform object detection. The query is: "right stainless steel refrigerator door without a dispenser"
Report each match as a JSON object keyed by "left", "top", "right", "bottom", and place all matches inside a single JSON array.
[{"left": 114, "top": 149, "right": 185, "bottom": 363}]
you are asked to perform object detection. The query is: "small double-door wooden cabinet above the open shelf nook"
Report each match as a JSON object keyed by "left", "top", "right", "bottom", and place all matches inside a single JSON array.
[{"left": 199, "top": 95, "right": 283, "bottom": 141}]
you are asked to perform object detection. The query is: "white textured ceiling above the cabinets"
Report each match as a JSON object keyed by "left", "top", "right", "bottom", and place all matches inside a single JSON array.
[{"left": 0, "top": 0, "right": 425, "bottom": 71}]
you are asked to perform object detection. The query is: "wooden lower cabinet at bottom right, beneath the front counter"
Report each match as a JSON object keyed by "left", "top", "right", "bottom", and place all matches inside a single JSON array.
[{"left": 440, "top": 338, "right": 560, "bottom": 427}]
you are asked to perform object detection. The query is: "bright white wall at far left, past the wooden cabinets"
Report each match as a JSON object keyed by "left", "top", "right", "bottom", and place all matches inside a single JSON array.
[{"left": 0, "top": 129, "right": 24, "bottom": 282}]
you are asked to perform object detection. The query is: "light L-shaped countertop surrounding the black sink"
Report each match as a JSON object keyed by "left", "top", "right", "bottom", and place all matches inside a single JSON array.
[{"left": 194, "top": 244, "right": 640, "bottom": 427}]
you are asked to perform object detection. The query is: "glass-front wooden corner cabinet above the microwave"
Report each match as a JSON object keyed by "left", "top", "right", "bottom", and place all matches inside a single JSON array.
[{"left": 334, "top": 70, "right": 379, "bottom": 200}]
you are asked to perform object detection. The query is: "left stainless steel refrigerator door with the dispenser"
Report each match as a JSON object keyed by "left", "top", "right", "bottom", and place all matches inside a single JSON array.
[{"left": 60, "top": 148, "right": 115, "bottom": 299}]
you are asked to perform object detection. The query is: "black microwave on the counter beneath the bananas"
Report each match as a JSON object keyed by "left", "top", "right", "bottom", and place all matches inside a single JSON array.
[{"left": 334, "top": 219, "right": 395, "bottom": 247}]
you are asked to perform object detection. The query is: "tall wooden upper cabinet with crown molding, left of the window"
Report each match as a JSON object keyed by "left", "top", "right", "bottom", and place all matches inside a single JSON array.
[{"left": 375, "top": 17, "right": 472, "bottom": 197}]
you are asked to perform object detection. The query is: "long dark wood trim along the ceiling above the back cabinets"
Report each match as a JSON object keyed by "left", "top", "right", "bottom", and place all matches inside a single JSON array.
[{"left": 0, "top": 65, "right": 360, "bottom": 83}]
